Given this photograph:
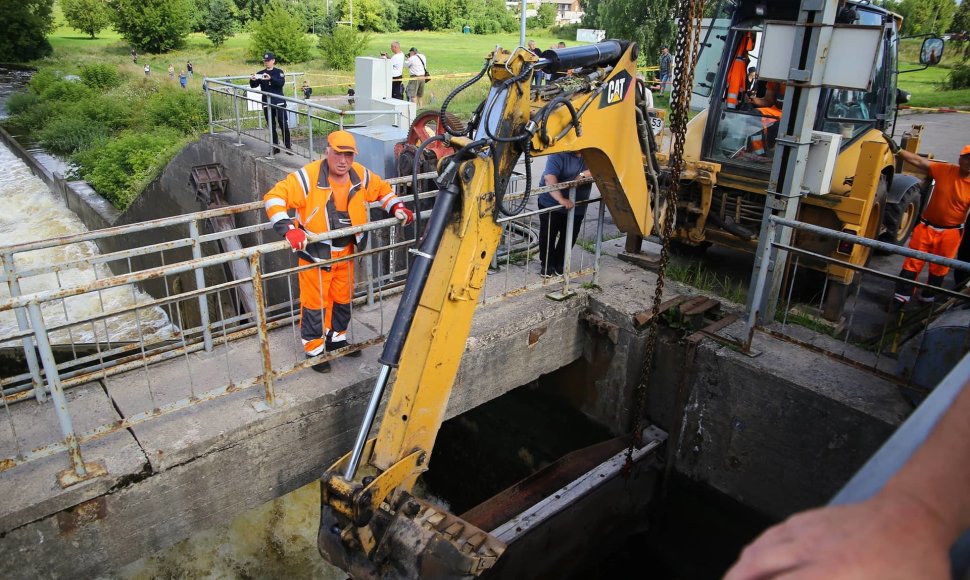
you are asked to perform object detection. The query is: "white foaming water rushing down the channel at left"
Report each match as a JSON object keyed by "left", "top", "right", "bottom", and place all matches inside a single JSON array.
[{"left": 0, "top": 144, "right": 176, "bottom": 344}]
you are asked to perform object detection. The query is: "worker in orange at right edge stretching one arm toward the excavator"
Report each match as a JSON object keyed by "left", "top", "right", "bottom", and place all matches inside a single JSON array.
[{"left": 890, "top": 145, "right": 970, "bottom": 309}]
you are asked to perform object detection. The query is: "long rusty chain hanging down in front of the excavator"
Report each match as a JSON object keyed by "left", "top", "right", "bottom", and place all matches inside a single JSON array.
[{"left": 624, "top": 0, "right": 705, "bottom": 472}]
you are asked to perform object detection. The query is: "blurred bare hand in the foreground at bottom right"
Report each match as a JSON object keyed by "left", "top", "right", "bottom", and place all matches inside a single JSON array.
[{"left": 724, "top": 491, "right": 952, "bottom": 580}]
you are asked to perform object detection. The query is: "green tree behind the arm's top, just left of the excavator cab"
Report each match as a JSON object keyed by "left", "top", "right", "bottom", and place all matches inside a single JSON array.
[{"left": 583, "top": 0, "right": 677, "bottom": 64}]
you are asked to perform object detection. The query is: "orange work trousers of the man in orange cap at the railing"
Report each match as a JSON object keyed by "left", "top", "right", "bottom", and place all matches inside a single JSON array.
[{"left": 299, "top": 246, "right": 354, "bottom": 356}]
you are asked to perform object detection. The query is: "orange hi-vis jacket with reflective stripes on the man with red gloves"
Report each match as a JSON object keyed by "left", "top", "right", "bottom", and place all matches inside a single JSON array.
[{"left": 263, "top": 160, "right": 400, "bottom": 262}]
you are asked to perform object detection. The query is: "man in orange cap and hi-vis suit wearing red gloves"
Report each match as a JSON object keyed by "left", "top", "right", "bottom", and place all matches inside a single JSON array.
[{"left": 263, "top": 131, "right": 414, "bottom": 373}]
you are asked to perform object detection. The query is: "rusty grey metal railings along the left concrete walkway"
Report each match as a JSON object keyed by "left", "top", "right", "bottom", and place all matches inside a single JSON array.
[{"left": 0, "top": 174, "right": 604, "bottom": 486}]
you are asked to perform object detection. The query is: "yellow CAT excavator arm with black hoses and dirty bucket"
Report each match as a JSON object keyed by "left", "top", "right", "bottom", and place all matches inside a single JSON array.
[{"left": 318, "top": 41, "right": 656, "bottom": 578}]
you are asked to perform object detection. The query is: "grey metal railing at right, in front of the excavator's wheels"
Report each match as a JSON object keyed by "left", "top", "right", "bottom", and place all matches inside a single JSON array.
[{"left": 744, "top": 216, "right": 970, "bottom": 394}]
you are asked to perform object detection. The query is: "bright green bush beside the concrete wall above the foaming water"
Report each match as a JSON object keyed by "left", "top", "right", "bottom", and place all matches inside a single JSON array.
[{"left": 73, "top": 128, "right": 184, "bottom": 210}]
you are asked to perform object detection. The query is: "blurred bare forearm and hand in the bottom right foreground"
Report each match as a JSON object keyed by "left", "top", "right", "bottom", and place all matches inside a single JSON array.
[{"left": 725, "top": 385, "right": 970, "bottom": 580}]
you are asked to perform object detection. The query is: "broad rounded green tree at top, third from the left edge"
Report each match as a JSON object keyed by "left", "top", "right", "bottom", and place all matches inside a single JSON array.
[{"left": 109, "top": 0, "right": 194, "bottom": 53}]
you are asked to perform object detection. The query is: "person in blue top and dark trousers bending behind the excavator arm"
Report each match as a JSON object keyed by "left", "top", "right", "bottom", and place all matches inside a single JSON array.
[{"left": 538, "top": 152, "right": 593, "bottom": 278}]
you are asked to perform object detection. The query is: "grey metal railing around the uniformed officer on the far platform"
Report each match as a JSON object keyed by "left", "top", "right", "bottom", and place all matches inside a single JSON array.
[{"left": 203, "top": 73, "right": 407, "bottom": 160}]
